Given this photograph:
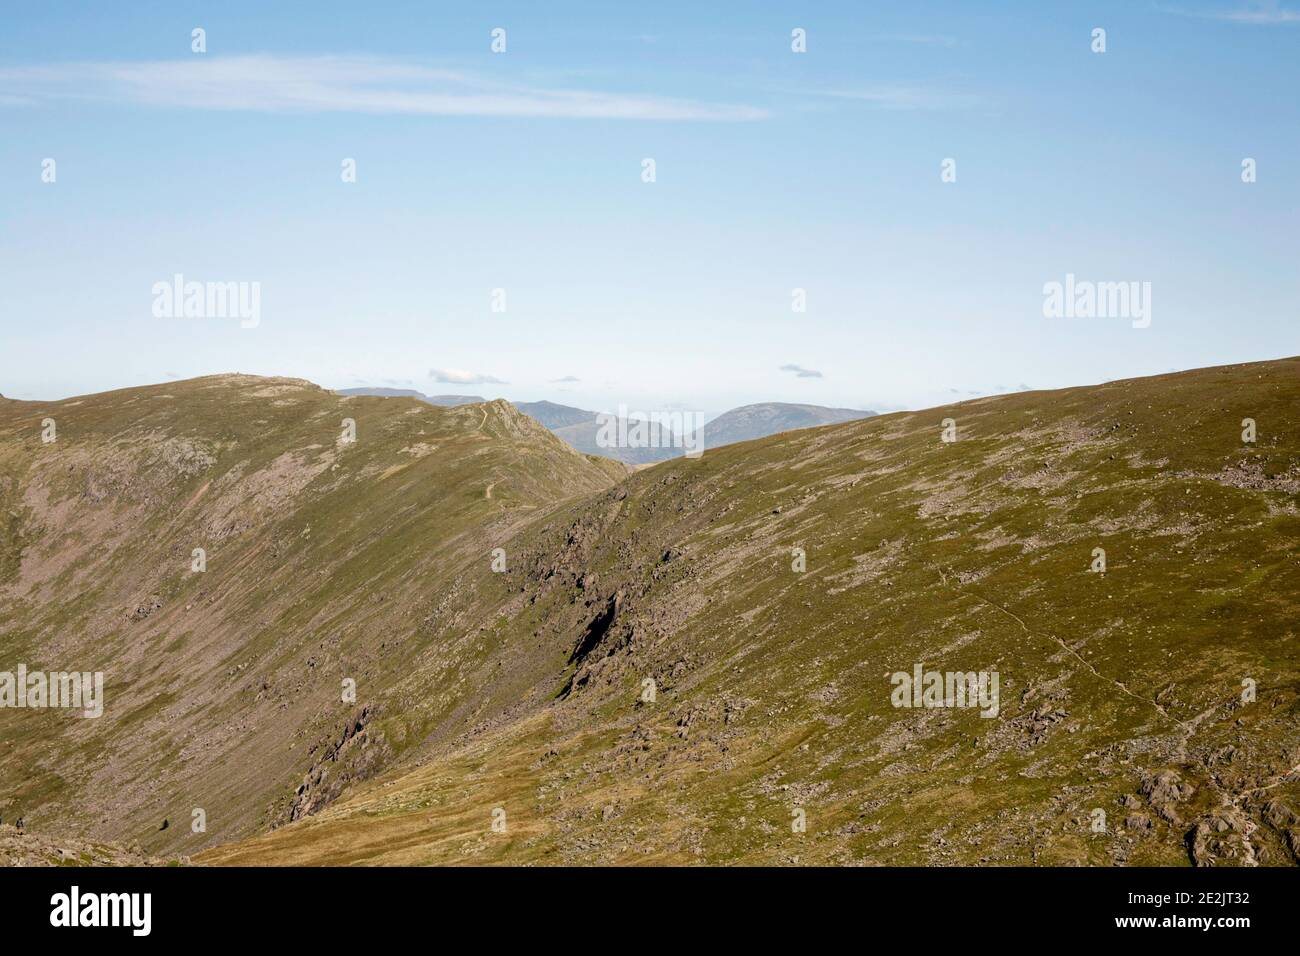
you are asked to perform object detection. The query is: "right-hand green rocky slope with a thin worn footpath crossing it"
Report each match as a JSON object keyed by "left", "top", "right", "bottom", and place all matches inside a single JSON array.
[{"left": 199, "top": 359, "right": 1300, "bottom": 865}]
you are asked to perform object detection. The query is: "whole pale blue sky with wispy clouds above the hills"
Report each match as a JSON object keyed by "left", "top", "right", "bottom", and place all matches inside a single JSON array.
[{"left": 0, "top": 0, "right": 1300, "bottom": 412}]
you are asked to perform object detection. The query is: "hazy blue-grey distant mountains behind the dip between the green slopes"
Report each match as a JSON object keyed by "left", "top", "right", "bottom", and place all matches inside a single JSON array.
[{"left": 338, "top": 388, "right": 876, "bottom": 464}]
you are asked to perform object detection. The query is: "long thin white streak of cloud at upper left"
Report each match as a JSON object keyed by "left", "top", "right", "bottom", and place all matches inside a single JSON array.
[{"left": 0, "top": 55, "right": 768, "bottom": 121}]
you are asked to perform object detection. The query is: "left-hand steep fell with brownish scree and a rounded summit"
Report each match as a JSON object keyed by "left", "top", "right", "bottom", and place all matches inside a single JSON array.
[{"left": 0, "top": 376, "right": 624, "bottom": 852}]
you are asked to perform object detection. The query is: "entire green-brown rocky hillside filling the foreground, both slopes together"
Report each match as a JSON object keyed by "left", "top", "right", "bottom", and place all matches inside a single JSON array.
[{"left": 0, "top": 359, "right": 1300, "bottom": 865}]
